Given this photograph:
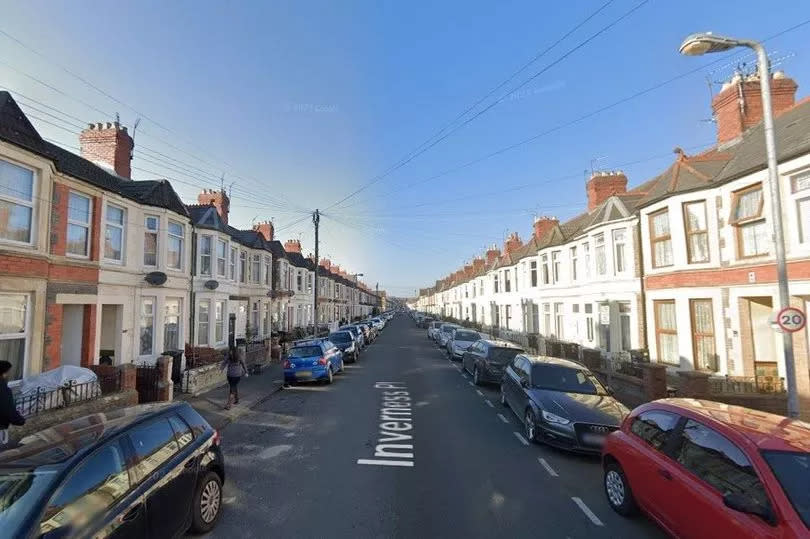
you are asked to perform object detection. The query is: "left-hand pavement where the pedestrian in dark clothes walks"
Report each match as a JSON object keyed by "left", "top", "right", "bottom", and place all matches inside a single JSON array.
[{"left": 174, "top": 363, "right": 284, "bottom": 430}]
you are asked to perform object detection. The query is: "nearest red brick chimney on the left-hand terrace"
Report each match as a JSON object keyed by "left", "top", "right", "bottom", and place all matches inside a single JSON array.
[{"left": 79, "top": 122, "right": 135, "bottom": 178}]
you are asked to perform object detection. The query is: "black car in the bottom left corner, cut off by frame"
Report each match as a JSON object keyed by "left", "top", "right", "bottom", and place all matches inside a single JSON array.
[{"left": 0, "top": 403, "right": 225, "bottom": 538}]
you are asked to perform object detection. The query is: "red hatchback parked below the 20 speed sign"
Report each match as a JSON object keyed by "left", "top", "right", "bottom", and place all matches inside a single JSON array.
[{"left": 602, "top": 399, "right": 810, "bottom": 539}]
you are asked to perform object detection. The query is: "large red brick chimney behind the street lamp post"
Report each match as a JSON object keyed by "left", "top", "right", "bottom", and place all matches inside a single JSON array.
[{"left": 712, "top": 71, "right": 798, "bottom": 144}]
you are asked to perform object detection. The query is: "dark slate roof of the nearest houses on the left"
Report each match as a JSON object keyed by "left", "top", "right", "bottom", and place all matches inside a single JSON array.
[{"left": 0, "top": 91, "right": 188, "bottom": 216}]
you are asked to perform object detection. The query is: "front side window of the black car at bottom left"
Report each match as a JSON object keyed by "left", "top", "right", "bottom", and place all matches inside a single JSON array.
[{"left": 39, "top": 442, "right": 129, "bottom": 533}]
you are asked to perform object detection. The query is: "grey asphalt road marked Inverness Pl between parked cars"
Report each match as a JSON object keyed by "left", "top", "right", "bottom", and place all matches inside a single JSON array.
[{"left": 205, "top": 316, "right": 663, "bottom": 538}]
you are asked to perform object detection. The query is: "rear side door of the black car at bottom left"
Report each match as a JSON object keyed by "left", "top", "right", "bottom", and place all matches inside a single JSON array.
[{"left": 127, "top": 417, "right": 197, "bottom": 537}]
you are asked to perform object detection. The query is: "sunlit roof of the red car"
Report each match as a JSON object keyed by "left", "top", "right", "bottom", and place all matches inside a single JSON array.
[{"left": 643, "top": 398, "right": 810, "bottom": 452}]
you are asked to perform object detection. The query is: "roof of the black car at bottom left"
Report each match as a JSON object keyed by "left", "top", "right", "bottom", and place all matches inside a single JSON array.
[{"left": 0, "top": 402, "right": 184, "bottom": 467}]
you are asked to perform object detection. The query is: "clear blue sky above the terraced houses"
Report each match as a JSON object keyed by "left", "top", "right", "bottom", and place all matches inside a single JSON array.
[{"left": 0, "top": 0, "right": 810, "bottom": 296}]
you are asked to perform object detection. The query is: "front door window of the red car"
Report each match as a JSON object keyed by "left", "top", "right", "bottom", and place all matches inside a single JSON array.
[{"left": 676, "top": 419, "right": 768, "bottom": 506}]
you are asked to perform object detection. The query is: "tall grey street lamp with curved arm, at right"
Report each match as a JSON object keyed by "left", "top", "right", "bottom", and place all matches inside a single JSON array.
[{"left": 680, "top": 32, "right": 799, "bottom": 417}]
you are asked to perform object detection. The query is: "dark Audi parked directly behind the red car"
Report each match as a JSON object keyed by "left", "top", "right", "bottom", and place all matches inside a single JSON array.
[{"left": 501, "top": 354, "right": 630, "bottom": 453}]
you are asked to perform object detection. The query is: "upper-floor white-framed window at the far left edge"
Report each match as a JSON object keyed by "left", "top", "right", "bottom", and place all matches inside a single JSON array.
[{"left": 0, "top": 160, "right": 34, "bottom": 243}]
